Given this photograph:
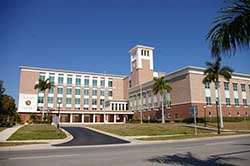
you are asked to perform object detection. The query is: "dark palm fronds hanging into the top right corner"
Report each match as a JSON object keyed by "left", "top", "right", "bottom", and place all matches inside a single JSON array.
[{"left": 206, "top": 0, "right": 250, "bottom": 57}]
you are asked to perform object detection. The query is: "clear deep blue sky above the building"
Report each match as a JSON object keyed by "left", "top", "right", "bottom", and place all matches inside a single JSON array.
[{"left": 0, "top": 0, "right": 250, "bottom": 102}]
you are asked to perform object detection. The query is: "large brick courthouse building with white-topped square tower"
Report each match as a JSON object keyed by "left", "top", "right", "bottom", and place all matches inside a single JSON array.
[{"left": 18, "top": 45, "right": 250, "bottom": 123}]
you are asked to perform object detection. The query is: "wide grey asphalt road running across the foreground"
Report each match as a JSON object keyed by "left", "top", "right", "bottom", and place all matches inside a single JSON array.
[{"left": 0, "top": 136, "right": 250, "bottom": 166}]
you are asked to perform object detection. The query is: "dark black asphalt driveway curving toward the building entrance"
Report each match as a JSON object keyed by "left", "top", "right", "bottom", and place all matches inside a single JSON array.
[{"left": 55, "top": 127, "right": 129, "bottom": 146}]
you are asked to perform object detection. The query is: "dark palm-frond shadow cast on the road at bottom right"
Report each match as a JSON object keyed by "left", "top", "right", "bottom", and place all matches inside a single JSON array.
[{"left": 148, "top": 152, "right": 245, "bottom": 166}]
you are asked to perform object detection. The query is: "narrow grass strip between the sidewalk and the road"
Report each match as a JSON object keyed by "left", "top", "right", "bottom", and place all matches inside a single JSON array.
[{"left": 137, "top": 133, "right": 249, "bottom": 141}]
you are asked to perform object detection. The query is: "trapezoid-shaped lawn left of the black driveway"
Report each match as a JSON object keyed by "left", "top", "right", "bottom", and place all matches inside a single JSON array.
[{"left": 8, "top": 124, "right": 66, "bottom": 140}]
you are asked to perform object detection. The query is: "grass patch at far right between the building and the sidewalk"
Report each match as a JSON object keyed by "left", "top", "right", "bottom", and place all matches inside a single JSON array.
[{"left": 199, "top": 120, "right": 250, "bottom": 130}]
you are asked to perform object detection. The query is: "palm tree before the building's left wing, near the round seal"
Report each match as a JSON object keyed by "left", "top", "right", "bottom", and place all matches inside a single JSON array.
[{"left": 34, "top": 79, "right": 54, "bottom": 119}]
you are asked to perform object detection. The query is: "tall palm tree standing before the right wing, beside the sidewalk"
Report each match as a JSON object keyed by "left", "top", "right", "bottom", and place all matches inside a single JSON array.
[{"left": 203, "top": 56, "right": 233, "bottom": 134}]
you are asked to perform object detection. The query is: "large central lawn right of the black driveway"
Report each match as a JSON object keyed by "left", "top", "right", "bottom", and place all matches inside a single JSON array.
[{"left": 89, "top": 123, "right": 213, "bottom": 136}]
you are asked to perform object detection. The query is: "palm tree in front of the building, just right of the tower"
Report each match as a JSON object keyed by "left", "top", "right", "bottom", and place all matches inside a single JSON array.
[{"left": 153, "top": 77, "right": 172, "bottom": 123}]
